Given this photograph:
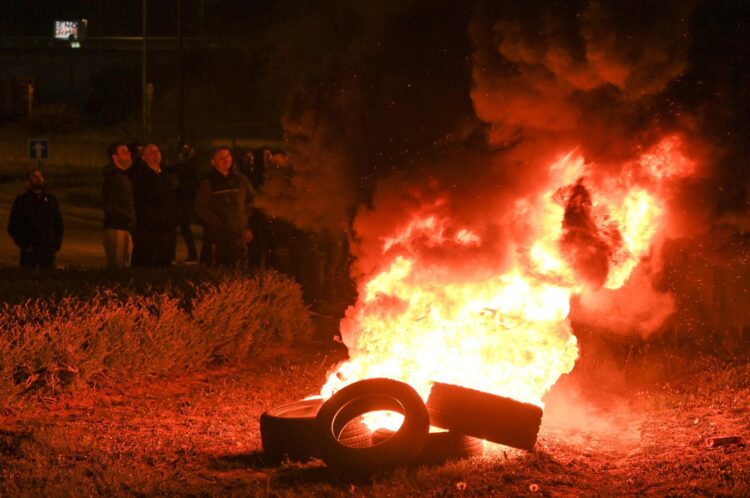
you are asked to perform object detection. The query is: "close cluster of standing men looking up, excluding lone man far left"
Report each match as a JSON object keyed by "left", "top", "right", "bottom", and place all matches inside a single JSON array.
[{"left": 102, "top": 143, "right": 264, "bottom": 267}]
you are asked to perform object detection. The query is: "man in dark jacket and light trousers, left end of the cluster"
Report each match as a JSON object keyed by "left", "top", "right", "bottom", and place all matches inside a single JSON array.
[{"left": 102, "top": 143, "right": 135, "bottom": 268}]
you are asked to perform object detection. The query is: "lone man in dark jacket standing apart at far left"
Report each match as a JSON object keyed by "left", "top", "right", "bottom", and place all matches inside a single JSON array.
[{"left": 8, "top": 169, "right": 63, "bottom": 268}]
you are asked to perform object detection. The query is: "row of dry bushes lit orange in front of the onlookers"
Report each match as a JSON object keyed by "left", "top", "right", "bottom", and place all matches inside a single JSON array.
[{"left": 0, "top": 273, "right": 312, "bottom": 404}]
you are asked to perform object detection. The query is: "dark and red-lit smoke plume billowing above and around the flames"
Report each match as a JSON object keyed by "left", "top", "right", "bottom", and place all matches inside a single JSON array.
[{"left": 266, "top": 0, "right": 750, "bottom": 336}]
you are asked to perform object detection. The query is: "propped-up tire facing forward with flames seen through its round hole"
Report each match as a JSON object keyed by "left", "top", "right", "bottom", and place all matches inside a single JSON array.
[{"left": 315, "top": 379, "right": 430, "bottom": 474}]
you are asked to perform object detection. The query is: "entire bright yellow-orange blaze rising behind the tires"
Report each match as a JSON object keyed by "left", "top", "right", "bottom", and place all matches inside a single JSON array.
[{"left": 322, "top": 137, "right": 692, "bottom": 414}]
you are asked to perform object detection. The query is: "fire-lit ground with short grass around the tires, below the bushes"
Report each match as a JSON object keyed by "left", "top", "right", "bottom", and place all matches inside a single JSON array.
[{"left": 0, "top": 318, "right": 750, "bottom": 497}]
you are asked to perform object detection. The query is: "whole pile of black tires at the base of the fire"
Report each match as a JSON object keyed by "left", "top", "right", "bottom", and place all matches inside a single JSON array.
[{"left": 260, "top": 378, "right": 541, "bottom": 475}]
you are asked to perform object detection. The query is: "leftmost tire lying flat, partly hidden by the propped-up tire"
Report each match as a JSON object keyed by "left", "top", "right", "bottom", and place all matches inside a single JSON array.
[{"left": 260, "top": 399, "right": 324, "bottom": 464}]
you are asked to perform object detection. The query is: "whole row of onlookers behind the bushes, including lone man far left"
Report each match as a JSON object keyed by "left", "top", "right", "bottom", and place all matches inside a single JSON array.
[{"left": 8, "top": 142, "right": 352, "bottom": 306}]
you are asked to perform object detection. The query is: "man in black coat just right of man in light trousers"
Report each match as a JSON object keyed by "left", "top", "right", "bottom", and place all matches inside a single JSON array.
[{"left": 132, "top": 144, "right": 177, "bottom": 266}]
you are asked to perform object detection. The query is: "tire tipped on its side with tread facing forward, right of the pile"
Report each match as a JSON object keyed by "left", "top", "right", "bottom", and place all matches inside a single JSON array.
[{"left": 427, "top": 382, "right": 542, "bottom": 451}]
